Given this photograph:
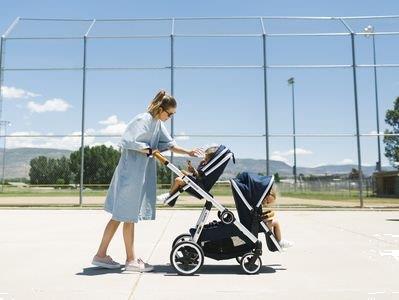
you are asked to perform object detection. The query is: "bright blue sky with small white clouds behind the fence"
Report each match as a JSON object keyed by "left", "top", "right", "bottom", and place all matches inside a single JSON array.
[{"left": 0, "top": 0, "right": 399, "bottom": 167}]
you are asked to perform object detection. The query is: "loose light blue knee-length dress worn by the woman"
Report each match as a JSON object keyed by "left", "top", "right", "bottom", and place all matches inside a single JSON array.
[{"left": 104, "top": 112, "right": 176, "bottom": 223}]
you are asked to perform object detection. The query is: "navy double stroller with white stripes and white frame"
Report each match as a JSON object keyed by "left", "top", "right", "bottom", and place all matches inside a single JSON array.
[{"left": 154, "top": 145, "right": 281, "bottom": 275}]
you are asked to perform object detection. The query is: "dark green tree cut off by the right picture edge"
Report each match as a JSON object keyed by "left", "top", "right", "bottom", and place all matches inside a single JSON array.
[{"left": 384, "top": 97, "right": 399, "bottom": 168}]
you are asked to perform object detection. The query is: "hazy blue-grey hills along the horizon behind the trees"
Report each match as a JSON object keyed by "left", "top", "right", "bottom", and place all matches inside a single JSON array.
[{"left": 0, "top": 148, "right": 394, "bottom": 179}]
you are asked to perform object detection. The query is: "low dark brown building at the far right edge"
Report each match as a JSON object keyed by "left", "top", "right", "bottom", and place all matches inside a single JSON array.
[{"left": 373, "top": 171, "right": 399, "bottom": 197}]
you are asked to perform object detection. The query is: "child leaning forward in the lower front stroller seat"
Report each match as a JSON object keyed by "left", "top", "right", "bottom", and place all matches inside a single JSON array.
[{"left": 262, "top": 185, "right": 293, "bottom": 249}]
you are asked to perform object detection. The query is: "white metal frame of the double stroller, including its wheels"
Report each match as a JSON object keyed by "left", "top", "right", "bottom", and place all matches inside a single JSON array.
[{"left": 153, "top": 152, "right": 281, "bottom": 275}]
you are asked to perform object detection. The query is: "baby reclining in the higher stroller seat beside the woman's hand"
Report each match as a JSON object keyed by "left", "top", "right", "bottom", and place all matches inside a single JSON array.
[{"left": 157, "top": 146, "right": 219, "bottom": 202}]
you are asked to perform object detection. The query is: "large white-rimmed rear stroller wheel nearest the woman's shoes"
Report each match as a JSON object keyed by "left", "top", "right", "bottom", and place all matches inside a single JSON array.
[{"left": 170, "top": 241, "right": 204, "bottom": 275}]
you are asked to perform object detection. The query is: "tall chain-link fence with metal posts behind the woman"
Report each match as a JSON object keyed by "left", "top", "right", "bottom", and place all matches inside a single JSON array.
[{"left": 0, "top": 16, "right": 399, "bottom": 207}]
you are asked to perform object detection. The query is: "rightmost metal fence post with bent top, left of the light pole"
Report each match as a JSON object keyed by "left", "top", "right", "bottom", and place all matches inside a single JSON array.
[{"left": 340, "top": 19, "right": 364, "bottom": 207}]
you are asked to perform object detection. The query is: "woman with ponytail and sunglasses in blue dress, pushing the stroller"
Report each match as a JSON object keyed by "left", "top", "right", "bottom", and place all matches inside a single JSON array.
[{"left": 92, "top": 91, "right": 201, "bottom": 272}]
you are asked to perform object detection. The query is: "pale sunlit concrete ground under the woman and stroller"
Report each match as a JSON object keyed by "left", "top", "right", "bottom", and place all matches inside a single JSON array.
[{"left": 0, "top": 209, "right": 399, "bottom": 300}]
